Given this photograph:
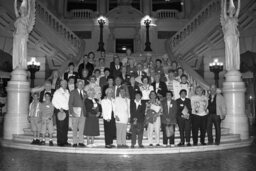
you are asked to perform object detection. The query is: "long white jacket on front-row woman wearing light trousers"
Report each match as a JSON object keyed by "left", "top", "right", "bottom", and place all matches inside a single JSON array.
[{"left": 114, "top": 97, "right": 130, "bottom": 124}]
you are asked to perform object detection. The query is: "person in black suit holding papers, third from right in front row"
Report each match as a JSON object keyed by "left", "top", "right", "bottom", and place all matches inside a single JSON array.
[{"left": 176, "top": 89, "right": 192, "bottom": 146}]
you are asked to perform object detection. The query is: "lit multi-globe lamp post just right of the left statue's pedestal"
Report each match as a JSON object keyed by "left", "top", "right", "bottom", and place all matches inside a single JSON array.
[{"left": 27, "top": 57, "right": 40, "bottom": 88}]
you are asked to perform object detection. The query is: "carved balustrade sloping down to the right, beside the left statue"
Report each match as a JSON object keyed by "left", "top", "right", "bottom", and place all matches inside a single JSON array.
[{"left": 36, "top": 1, "right": 82, "bottom": 48}]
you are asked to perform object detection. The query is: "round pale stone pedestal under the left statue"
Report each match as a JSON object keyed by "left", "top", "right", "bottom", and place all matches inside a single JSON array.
[{"left": 4, "top": 69, "right": 30, "bottom": 139}]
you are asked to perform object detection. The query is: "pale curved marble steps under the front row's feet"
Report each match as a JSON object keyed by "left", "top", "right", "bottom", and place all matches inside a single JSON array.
[{"left": 0, "top": 119, "right": 252, "bottom": 155}]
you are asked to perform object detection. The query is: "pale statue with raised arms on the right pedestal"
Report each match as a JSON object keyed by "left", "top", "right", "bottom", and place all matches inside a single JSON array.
[{"left": 220, "top": 0, "right": 241, "bottom": 71}]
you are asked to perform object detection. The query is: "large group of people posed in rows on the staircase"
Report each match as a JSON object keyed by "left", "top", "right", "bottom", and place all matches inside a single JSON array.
[{"left": 29, "top": 49, "right": 226, "bottom": 148}]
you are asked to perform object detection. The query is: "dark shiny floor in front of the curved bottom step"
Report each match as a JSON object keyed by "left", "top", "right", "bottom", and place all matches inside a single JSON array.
[{"left": 0, "top": 145, "right": 256, "bottom": 171}]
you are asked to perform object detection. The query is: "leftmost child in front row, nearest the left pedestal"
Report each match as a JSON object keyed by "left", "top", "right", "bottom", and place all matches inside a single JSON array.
[{"left": 28, "top": 93, "right": 40, "bottom": 144}]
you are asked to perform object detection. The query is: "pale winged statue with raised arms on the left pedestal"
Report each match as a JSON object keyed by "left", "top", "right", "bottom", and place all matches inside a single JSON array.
[{"left": 12, "top": 0, "right": 35, "bottom": 69}]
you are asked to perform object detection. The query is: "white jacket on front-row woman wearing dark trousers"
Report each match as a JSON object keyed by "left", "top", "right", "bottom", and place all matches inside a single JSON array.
[{"left": 101, "top": 98, "right": 115, "bottom": 120}]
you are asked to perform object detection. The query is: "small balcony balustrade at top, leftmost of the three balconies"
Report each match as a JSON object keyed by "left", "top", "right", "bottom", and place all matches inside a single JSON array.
[{"left": 70, "top": 9, "right": 94, "bottom": 19}]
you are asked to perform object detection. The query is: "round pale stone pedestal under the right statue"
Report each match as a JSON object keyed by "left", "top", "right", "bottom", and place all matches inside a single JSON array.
[{"left": 222, "top": 71, "right": 249, "bottom": 139}]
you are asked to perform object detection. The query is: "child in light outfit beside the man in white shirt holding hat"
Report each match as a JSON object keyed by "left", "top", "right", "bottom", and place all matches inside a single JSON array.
[{"left": 39, "top": 92, "right": 54, "bottom": 146}]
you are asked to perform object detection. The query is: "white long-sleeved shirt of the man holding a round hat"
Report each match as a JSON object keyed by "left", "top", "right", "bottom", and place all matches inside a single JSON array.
[{"left": 52, "top": 88, "right": 69, "bottom": 110}]
